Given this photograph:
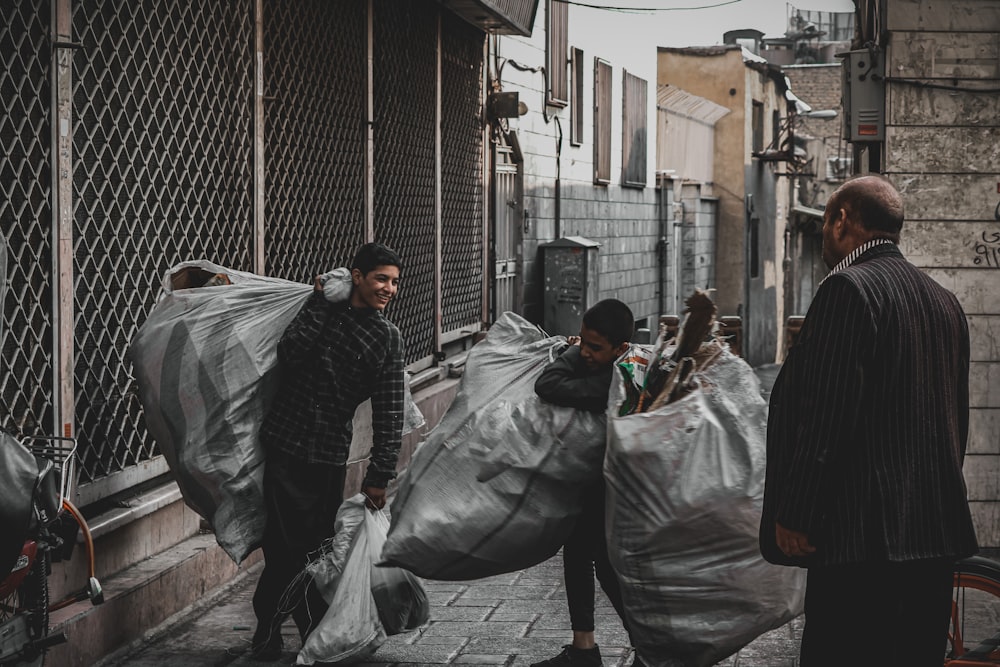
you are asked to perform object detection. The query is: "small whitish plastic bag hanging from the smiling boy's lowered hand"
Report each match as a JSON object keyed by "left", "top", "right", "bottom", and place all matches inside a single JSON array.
[{"left": 296, "top": 494, "right": 430, "bottom": 665}]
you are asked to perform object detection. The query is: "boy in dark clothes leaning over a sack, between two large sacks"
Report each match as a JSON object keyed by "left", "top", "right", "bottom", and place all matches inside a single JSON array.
[{"left": 531, "top": 299, "right": 642, "bottom": 667}]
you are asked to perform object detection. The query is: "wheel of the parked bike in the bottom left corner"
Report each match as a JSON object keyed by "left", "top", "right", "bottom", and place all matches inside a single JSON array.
[{"left": 0, "top": 549, "right": 51, "bottom": 667}]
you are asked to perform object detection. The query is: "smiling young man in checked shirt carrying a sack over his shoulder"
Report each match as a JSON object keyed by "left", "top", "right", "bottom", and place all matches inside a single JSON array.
[{"left": 251, "top": 243, "right": 404, "bottom": 661}]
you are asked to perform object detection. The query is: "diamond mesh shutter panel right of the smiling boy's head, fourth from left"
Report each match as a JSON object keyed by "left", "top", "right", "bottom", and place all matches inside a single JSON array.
[{"left": 373, "top": 0, "right": 437, "bottom": 362}]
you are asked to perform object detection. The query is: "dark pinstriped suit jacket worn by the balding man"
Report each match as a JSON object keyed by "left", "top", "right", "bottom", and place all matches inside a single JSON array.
[{"left": 760, "top": 243, "right": 978, "bottom": 566}]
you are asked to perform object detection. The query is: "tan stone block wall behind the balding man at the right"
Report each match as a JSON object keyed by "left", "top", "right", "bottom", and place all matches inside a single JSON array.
[{"left": 884, "top": 0, "right": 1000, "bottom": 548}]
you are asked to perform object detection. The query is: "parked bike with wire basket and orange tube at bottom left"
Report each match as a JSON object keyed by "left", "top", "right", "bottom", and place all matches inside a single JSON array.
[{"left": 0, "top": 430, "right": 104, "bottom": 667}]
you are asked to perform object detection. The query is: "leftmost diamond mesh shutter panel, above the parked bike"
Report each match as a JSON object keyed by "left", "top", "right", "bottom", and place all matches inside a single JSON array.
[{"left": 0, "top": 0, "right": 54, "bottom": 434}]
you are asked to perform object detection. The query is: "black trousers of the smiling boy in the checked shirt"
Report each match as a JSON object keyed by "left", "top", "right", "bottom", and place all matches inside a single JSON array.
[{"left": 253, "top": 454, "right": 346, "bottom": 643}]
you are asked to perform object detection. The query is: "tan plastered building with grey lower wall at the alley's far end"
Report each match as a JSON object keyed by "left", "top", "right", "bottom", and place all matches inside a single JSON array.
[{"left": 657, "top": 44, "right": 794, "bottom": 365}]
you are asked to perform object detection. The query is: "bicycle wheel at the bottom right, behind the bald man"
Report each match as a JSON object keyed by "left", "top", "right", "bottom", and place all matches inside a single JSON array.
[{"left": 944, "top": 556, "right": 1000, "bottom": 667}]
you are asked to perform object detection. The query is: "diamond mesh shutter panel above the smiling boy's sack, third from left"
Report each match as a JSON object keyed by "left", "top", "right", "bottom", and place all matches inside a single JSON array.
[{"left": 264, "top": 0, "right": 367, "bottom": 283}]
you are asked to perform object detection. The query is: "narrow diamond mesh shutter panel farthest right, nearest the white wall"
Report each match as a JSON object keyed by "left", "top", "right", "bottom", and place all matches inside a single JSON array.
[{"left": 441, "top": 13, "right": 484, "bottom": 332}]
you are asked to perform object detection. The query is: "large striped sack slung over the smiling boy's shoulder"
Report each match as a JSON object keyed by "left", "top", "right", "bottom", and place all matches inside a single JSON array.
[{"left": 128, "top": 260, "right": 423, "bottom": 563}]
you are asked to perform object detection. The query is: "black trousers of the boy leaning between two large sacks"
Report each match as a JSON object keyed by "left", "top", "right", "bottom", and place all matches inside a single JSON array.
[{"left": 563, "top": 479, "right": 628, "bottom": 632}]
